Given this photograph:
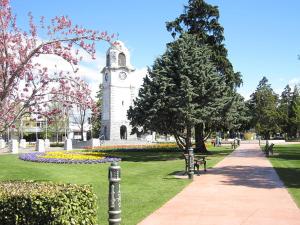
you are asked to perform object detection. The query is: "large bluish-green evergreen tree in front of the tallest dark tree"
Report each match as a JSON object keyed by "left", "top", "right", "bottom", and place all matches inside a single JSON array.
[{"left": 128, "top": 34, "right": 231, "bottom": 150}]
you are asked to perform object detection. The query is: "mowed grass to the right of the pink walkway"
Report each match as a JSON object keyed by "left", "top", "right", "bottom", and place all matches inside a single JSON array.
[{"left": 270, "top": 144, "right": 300, "bottom": 208}]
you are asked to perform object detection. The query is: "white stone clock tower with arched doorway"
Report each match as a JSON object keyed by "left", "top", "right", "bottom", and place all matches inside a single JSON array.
[{"left": 101, "top": 41, "right": 136, "bottom": 140}]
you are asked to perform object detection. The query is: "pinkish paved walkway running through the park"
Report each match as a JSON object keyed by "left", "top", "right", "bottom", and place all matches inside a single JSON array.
[{"left": 139, "top": 144, "right": 300, "bottom": 225}]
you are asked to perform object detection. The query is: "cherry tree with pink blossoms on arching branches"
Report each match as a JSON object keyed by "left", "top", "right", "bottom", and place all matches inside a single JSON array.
[{"left": 0, "top": 0, "right": 114, "bottom": 132}]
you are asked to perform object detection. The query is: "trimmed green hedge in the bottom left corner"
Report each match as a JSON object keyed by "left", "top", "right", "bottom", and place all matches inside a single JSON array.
[{"left": 0, "top": 181, "right": 97, "bottom": 225}]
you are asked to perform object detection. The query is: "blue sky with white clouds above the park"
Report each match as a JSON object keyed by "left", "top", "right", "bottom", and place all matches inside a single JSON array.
[{"left": 11, "top": 0, "right": 300, "bottom": 99}]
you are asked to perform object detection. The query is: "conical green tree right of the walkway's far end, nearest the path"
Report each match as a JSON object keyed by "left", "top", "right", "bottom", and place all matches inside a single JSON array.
[{"left": 249, "top": 77, "right": 280, "bottom": 139}]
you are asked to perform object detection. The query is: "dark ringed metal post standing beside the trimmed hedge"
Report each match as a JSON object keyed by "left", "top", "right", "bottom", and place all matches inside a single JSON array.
[{"left": 108, "top": 162, "right": 121, "bottom": 225}]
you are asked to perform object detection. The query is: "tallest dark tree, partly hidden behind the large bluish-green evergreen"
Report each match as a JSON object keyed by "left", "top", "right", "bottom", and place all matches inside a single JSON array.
[{"left": 166, "top": 0, "right": 242, "bottom": 151}]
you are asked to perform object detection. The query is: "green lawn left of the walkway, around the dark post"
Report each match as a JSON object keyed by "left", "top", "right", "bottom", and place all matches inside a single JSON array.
[{"left": 0, "top": 147, "right": 231, "bottom": 225}]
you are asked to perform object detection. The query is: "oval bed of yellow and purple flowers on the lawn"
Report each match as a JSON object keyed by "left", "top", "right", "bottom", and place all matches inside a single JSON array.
[{"left": 19, "top": 151, "right": 121, "bottom": 164}]
